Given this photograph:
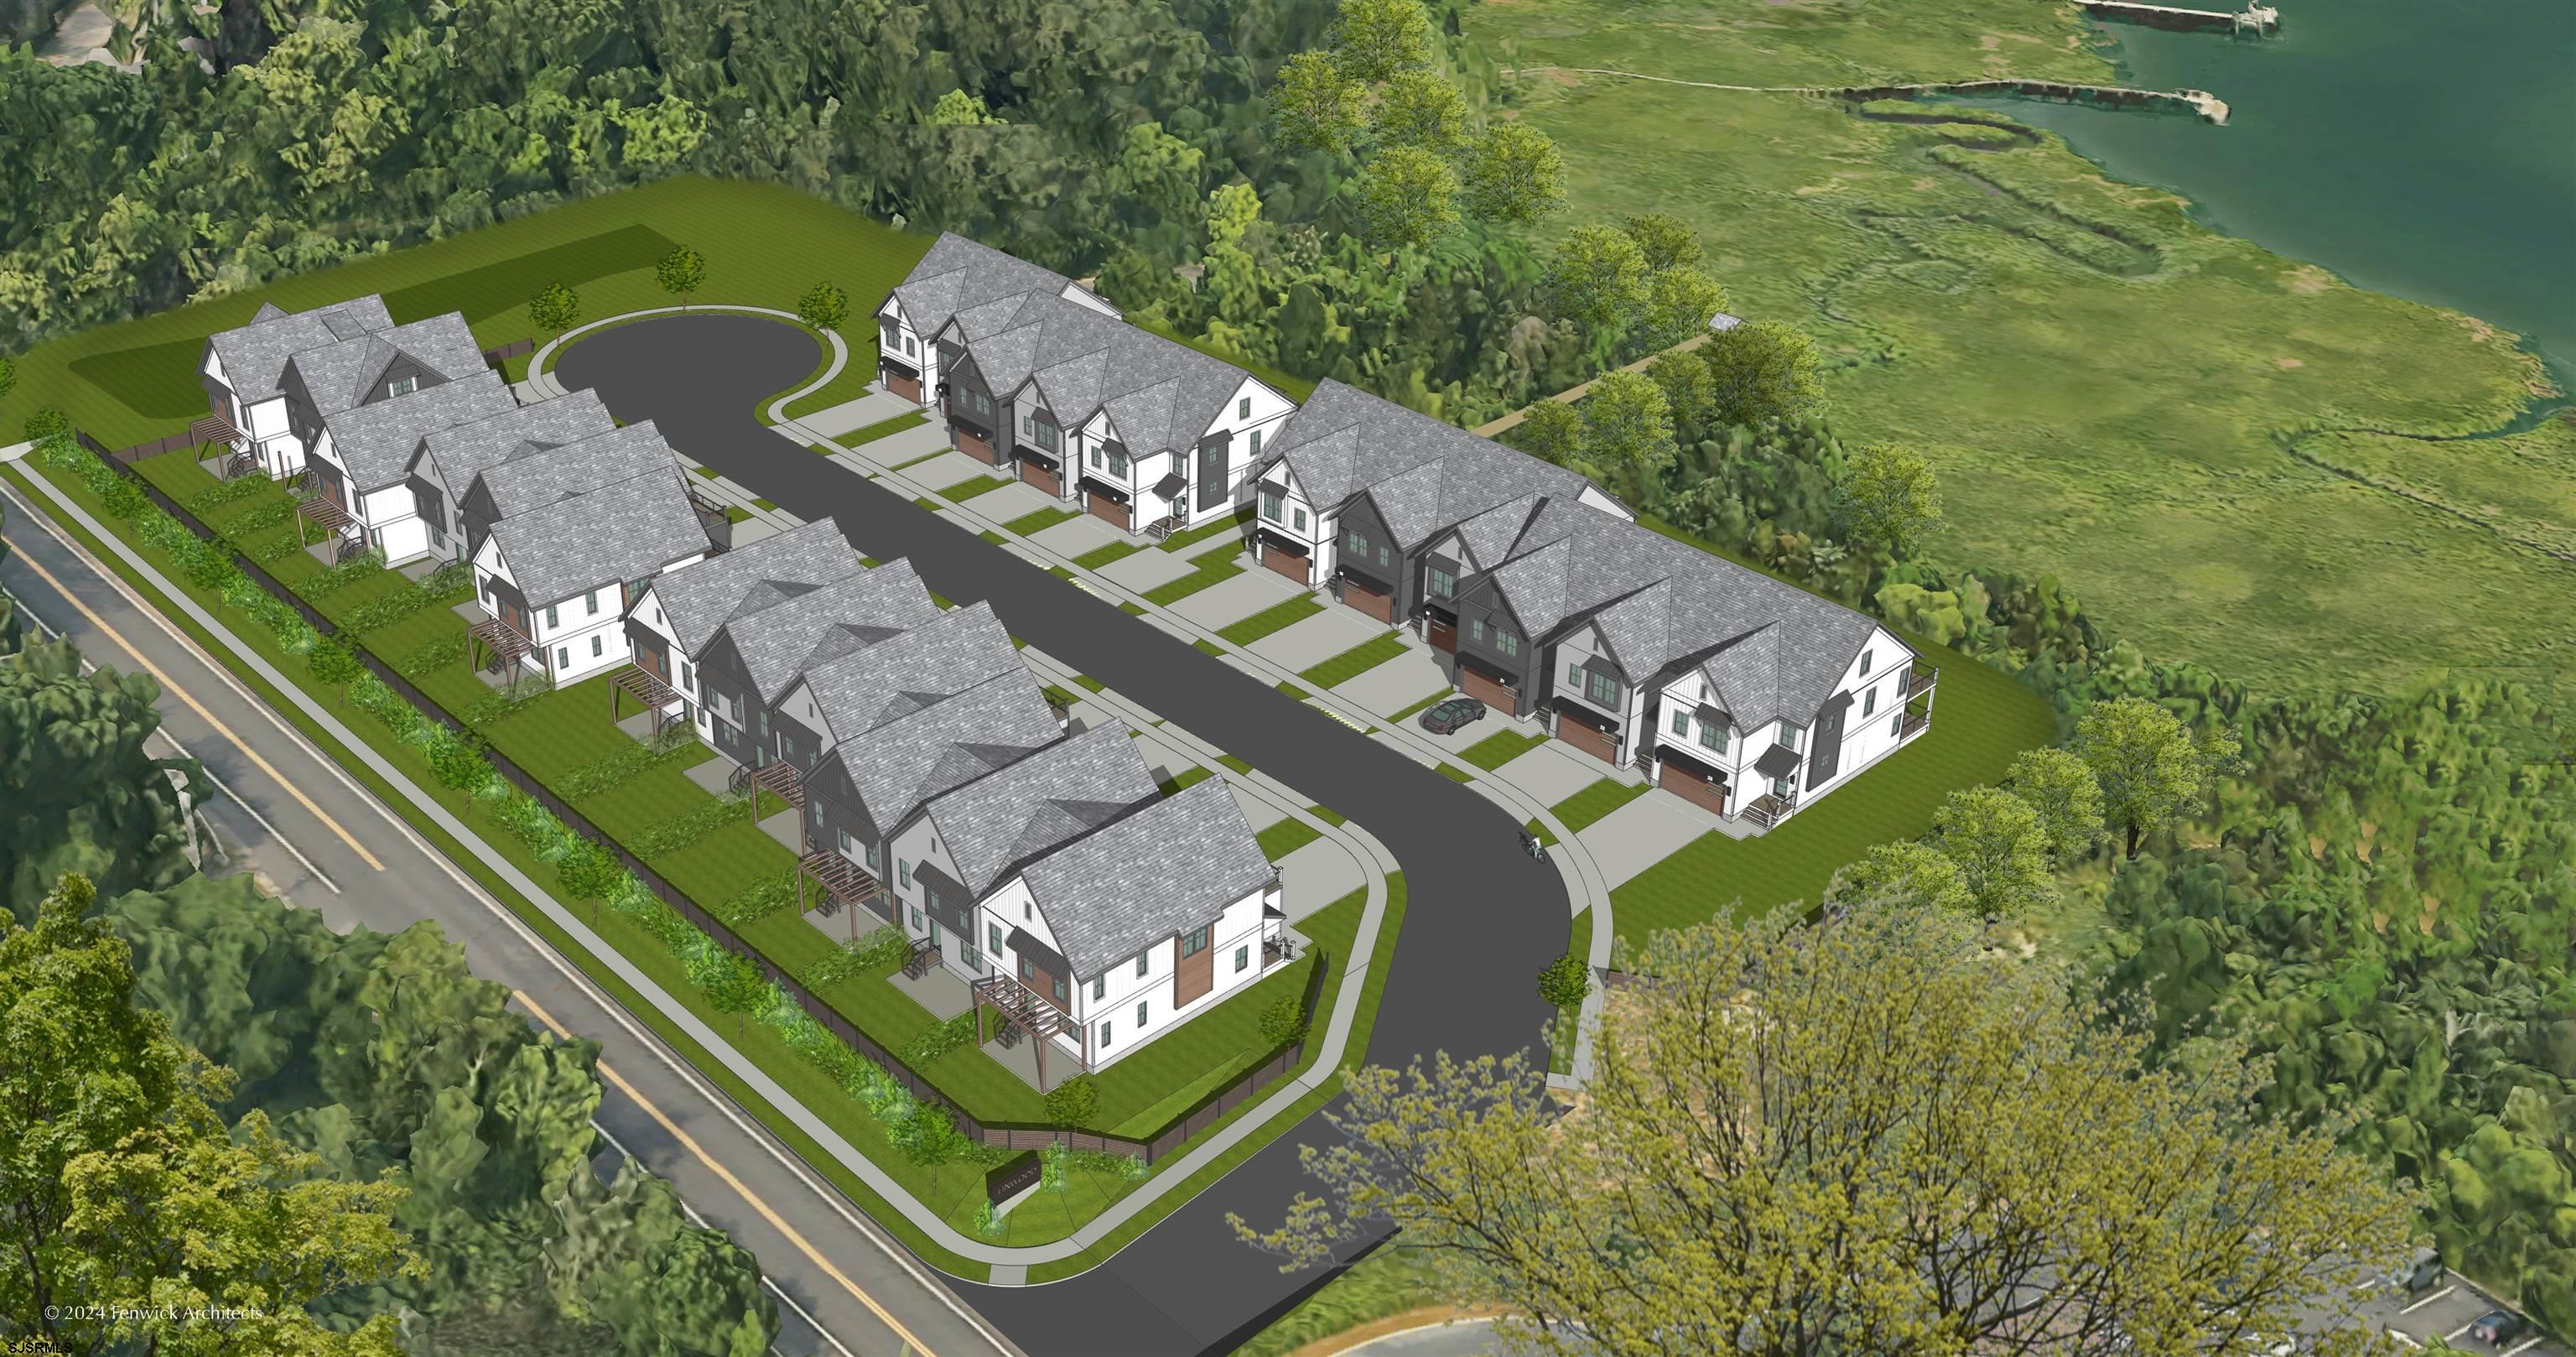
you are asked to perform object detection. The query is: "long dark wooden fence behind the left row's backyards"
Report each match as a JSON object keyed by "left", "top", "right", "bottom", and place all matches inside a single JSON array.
[{"left": 80, "top": 443, "right": 1332, "bottom": 1164}]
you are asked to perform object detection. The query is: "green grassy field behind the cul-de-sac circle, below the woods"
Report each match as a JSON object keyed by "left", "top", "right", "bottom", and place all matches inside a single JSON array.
[{"left": 0, "top": 178, "right": 930, "bottom": 448}]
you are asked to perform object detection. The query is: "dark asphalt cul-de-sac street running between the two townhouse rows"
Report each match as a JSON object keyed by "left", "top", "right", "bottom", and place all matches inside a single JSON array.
[{"left": 553, "top": 315, "right": 1569, "bottom": 1357}]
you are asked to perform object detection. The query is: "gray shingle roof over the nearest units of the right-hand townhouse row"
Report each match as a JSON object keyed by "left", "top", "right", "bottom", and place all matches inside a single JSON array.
[{"left": 1492, "top": 500, "right": 1877, "bottom": 729}]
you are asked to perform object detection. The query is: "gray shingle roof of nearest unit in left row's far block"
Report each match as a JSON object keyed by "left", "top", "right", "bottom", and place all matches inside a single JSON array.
[{"left": 492, "top": 469, "right": 709, "bottom": 608}]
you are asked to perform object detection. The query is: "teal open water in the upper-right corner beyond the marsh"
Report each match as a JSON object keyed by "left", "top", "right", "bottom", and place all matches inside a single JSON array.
[{"left": 1978, "top": 0, "right": 2576, "bottom": 387}]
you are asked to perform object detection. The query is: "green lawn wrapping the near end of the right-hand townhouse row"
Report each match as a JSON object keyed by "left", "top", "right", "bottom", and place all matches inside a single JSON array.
[{"left": 1610, "top": 638, "right": 2055, "bottom": 943}]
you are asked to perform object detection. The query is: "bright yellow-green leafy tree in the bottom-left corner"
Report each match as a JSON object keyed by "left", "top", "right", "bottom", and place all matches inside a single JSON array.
[{"left": 0, "top": 876, "right": 418, "bottom": 1357}]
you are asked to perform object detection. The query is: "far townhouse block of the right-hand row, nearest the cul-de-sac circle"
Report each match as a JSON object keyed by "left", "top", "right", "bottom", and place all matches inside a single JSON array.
[{"left": 879, "top": 237, "right": 1296, "bottom": 533}]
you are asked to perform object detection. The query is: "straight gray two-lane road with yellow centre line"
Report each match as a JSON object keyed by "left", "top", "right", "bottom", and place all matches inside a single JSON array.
[{"left": 0, "top": 486, "right": 1012, "bottom": 1357}]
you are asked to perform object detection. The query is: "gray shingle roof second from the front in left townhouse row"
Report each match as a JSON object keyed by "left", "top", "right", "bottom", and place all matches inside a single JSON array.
[{"left": 925, "top": 721, "right": 1161, "bottom": 899}]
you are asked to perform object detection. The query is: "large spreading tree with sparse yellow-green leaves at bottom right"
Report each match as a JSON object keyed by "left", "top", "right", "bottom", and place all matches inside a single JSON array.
[{"left": 1228, "top": 902, "right": 2413, "bottom": 1357}]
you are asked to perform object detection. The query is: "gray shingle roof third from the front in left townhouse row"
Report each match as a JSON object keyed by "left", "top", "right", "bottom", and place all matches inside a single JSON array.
[{"left": 832, "top": 669, "right": 1064, "bottom": 827}]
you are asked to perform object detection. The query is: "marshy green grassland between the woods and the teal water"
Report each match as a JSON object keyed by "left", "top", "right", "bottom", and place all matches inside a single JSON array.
[{"left": 1466, "top": 0, "right": 2576, "bottom": 710}]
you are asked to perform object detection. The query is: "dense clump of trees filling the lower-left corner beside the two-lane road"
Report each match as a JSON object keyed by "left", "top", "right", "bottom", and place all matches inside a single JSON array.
[{"left": 0, "top": 525, "right": 778, "bottom": 1357}]
